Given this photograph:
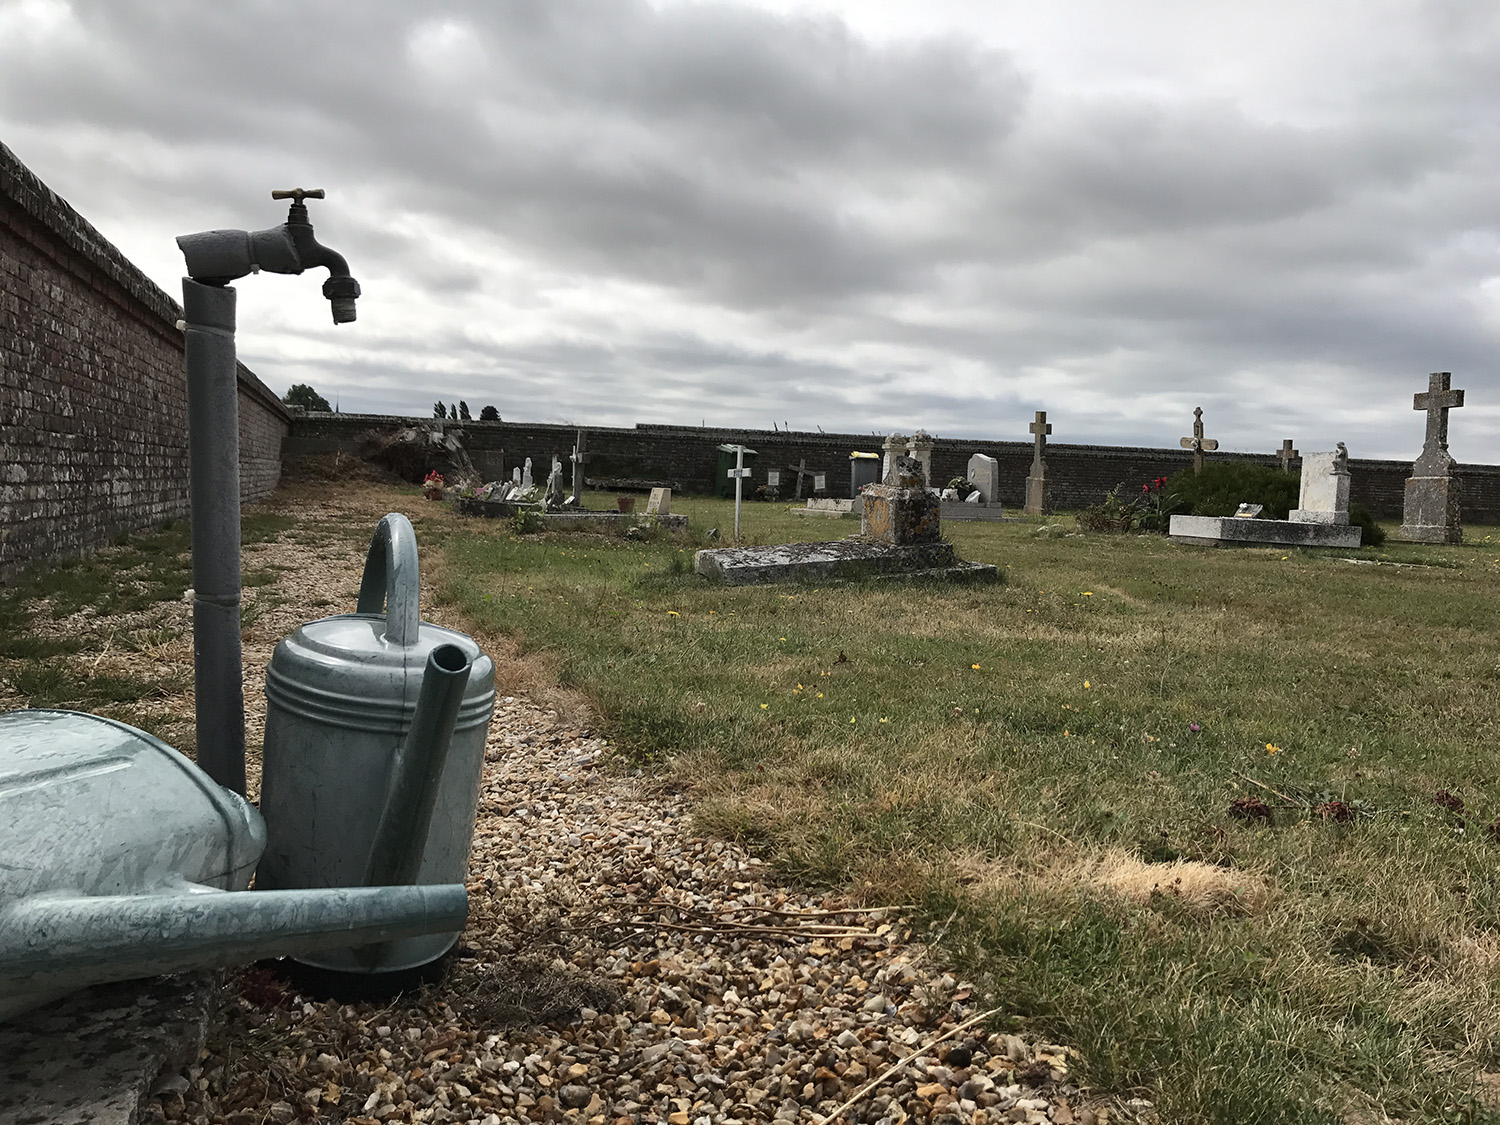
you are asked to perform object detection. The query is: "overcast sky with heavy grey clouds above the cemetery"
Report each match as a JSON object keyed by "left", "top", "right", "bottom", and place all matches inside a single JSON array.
[{"left": 0, "top": 0, "right": 1500, "bottom": 462}]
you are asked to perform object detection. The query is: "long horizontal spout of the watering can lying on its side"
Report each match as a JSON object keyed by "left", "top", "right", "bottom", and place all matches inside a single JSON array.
[{"left": 0, "top": 884, "right": 468, "bottom": 1020}]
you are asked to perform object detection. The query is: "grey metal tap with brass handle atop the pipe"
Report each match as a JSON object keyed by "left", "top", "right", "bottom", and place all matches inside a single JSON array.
[{"left": 177, "top": 188, "right": 360, "bottom": 324}]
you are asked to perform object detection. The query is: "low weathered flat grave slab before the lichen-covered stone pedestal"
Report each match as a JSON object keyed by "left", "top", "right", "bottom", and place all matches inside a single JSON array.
[{"left": 693, "top": 539, "right": 999, "bottom": 587}]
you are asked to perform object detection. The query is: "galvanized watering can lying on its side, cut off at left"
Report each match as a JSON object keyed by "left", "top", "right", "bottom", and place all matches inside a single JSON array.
[{"left": 0, "top": 711, "right": 468, "bottom": 1020}]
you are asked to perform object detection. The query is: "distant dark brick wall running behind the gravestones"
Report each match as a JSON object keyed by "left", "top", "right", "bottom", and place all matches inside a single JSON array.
[{"left": 287, "top": 414, "right": 1500, "bottom": 524}]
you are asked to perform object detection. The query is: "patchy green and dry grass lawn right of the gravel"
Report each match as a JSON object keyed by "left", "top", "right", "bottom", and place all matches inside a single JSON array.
[{"left": 434, "top": 498, "right": 1500, "bottom": 1124}]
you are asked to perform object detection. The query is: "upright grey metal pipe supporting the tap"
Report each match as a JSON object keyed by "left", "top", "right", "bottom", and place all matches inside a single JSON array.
[{"left": 183, "top": 278, "right": 245, "bottom": 797}]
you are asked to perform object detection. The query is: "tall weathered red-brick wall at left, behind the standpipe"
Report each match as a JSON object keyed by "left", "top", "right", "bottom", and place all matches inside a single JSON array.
[{"left": 0, "top": 146, "right": 291, "bottom": 579}]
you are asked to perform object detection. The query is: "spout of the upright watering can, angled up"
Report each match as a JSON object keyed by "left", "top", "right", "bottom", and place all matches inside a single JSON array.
[{"left": 365, "top": 645, "right": 473, "bottom": 887}]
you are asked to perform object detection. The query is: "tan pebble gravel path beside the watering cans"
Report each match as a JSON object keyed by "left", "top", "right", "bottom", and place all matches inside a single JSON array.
[{"left": 150, "top": 486, "right": 1128, "bottom": 1125}]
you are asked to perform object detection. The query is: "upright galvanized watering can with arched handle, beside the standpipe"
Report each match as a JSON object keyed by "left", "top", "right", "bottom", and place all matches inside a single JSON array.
[{"left": 255, "top": 513, "right": 495, "bottom": 974}]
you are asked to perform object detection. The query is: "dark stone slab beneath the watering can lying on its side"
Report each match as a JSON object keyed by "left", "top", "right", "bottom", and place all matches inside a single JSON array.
[{"left": 0, "top": 974, "right": 218, "bottom": 1125}]
